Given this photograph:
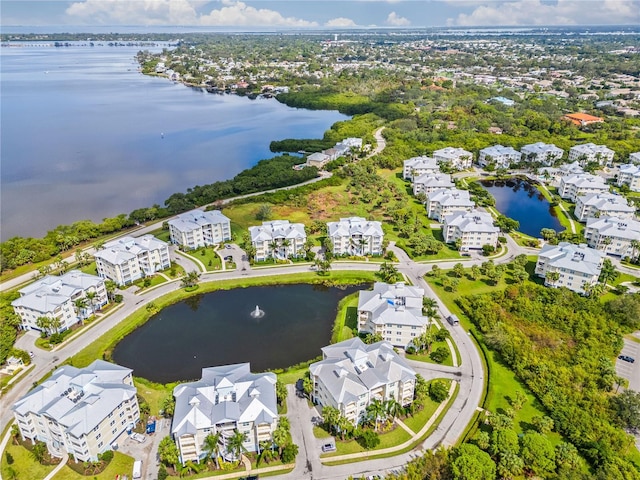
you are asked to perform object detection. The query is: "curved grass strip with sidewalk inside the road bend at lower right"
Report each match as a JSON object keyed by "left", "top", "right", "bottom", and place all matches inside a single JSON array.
[{"left": 314, "top": 380, "right": 459, "bottom": 465}]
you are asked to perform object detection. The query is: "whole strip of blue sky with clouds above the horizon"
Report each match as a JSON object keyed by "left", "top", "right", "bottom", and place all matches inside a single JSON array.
[{"left": 0, "top": 0, "right": 640, "bottom": 29}]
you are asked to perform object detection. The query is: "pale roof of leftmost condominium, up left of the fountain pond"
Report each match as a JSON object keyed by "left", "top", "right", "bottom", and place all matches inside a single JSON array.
[{"left": 11, "top": 270, "right": 104, "bottom": 313}]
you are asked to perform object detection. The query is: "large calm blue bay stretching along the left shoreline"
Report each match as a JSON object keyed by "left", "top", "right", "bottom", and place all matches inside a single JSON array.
[{"left": 0, "top": 46, "right": 347, "bottom": 240}]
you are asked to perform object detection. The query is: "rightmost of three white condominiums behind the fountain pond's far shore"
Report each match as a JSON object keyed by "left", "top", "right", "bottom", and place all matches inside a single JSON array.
[{"left": 327, "top": 217, "right": 384, "bottom": 256}]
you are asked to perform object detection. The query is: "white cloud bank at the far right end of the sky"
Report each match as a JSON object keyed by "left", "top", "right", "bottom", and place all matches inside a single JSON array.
[{"left": 448, "top": 0, "right": 640, "bottom": 26}]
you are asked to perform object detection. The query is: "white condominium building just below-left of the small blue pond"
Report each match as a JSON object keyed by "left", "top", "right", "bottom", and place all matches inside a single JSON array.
[{"left": 442, "top": 210, "right": 500, "bottom": 252}]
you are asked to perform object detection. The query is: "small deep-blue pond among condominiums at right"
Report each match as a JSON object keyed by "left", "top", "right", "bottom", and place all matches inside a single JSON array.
[{"left": 481, "top": 178, "right": 563, "bottom": 237}]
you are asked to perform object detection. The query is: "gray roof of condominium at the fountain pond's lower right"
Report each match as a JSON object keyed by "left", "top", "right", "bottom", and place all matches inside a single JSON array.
[{"left": 309, "top": 338, "right": 416, "bottom": 404}]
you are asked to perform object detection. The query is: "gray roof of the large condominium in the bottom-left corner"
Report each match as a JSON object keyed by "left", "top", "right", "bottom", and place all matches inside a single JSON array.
[{"left": 12, "top": 360, "right": 136, "bottom": 438}]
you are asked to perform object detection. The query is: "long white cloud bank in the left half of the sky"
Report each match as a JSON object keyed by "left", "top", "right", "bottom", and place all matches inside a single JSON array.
[{"left": 66, "top": 0, "right": 318, "bottom": 27}]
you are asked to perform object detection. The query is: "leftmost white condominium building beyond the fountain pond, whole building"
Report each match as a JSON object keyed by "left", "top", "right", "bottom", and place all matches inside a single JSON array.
[{"left": 11, "top": 270, "right": 108, "bottom": 333}]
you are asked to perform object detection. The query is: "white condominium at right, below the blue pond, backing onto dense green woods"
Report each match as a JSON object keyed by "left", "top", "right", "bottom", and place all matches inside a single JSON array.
[{"left": 535, "top": 242, "right": 605, "bottom": 293}]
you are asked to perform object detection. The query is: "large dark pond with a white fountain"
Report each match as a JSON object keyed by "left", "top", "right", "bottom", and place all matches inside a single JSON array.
[{"left": 113, "top": 284, "right": 367, "bottom": 383}]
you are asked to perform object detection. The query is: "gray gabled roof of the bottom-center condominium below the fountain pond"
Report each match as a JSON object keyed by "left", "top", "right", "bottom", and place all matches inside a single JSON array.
[{"left": 171, "top": 363, "right": 278, "bottom": 436}]
